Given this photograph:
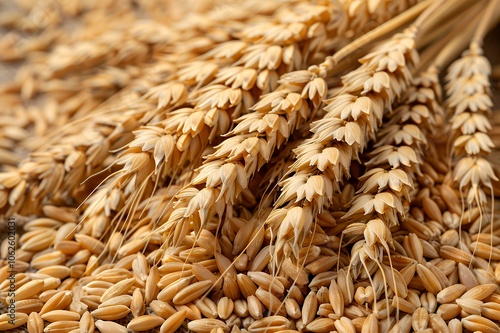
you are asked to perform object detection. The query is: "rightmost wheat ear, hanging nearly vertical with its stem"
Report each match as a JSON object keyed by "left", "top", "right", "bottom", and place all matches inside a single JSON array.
[{"left": 446, "top": 1, "right": 498, "bottom": 230}]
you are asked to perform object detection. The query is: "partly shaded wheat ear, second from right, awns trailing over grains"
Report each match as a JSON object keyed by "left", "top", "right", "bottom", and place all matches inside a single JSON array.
[{"left": 334, "top": 68, "right": 439, "bottom": 317}]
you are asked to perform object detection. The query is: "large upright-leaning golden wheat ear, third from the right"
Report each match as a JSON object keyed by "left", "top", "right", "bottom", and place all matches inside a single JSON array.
[{"left": 267, "top": 28, "right": 418, "bottom": 263}]
